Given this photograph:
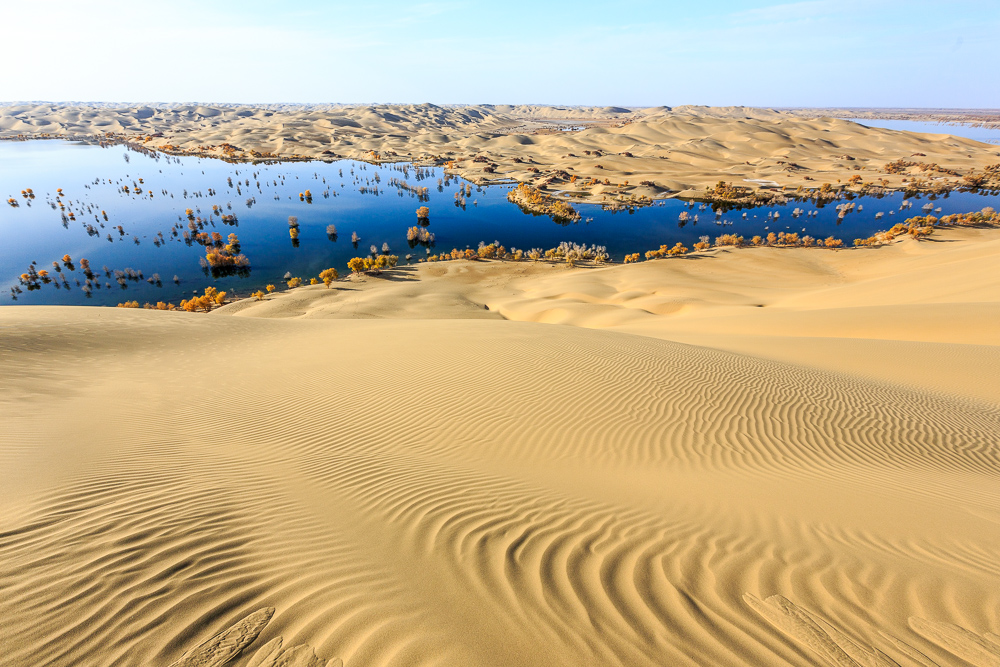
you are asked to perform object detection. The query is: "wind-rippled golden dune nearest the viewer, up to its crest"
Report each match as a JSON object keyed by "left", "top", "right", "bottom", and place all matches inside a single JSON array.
[{"left": 0, "top": 313, "right": 1000, "bottom": 667}]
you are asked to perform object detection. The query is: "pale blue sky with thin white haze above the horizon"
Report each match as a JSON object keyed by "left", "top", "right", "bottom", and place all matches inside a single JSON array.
[{"left": 0, "top": 0, "right": 1000, "bottom": 108}]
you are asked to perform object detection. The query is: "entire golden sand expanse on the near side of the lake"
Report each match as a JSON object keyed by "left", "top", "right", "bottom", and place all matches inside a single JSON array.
[{"left": 0, "top": 229, "right": 1000, "bottom": 667}]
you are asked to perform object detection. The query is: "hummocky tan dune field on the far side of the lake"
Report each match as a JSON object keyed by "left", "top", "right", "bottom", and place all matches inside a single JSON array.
[{"left": 0, "top": 104, "right": 1000, "bottom": 204}]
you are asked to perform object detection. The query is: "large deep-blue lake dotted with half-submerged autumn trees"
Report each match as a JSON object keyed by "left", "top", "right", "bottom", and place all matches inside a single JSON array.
[{"left": 0, "top": 141, "right": 1000, "bottom": 305}]
